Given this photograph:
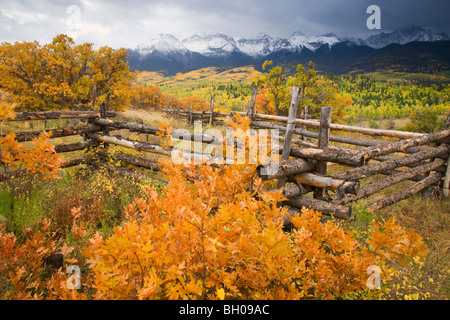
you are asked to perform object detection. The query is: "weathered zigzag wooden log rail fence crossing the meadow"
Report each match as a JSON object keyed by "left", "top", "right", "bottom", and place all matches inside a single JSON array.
[{"left": 0, "top": 94, "right": 450, "bottom": 220}]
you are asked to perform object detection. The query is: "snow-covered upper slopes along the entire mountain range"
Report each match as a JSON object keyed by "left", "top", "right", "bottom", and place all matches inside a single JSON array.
[{"left": 136, "top": 26, "right": 450, "bottom": 58}]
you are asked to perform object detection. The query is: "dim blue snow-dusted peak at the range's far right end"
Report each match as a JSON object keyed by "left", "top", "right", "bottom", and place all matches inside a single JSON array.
[{"left": 364, "top": 26, "right": 450, "bottom": 49}]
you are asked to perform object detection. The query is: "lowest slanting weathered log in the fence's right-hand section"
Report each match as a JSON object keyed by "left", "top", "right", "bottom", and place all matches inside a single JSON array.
[{"left": 367, "top": 172, "right": 444, "bottom": 211}]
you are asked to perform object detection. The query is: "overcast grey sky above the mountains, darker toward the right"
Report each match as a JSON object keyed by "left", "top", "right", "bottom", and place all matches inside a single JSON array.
[{"left": 0, "top": 0, "right": 450, "bottom": 48}]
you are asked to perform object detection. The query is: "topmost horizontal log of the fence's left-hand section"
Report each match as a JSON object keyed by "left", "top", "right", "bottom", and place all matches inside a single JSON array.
[{"left": 12, "top": 111, "right": 116, "bottom": 121}]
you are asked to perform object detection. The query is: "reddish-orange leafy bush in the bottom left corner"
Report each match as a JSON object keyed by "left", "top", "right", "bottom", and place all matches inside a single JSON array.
[{"left": 0, "top": 219, "right": 87, "bottom": 300}]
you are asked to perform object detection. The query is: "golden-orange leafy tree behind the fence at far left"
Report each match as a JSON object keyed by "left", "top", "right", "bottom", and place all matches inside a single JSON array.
[{"left": 0, "top": 34, "right": 135, "bottom": 111}]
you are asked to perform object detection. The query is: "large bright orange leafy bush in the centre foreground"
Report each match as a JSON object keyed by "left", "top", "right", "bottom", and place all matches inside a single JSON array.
[{"left": 84, "top": 162, "right": 425, "bottom": 299}]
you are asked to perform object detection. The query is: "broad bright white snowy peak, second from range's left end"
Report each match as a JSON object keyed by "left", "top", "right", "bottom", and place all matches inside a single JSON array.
[{"left": 183, "top": 33, "right": 239, "bottom": 57}]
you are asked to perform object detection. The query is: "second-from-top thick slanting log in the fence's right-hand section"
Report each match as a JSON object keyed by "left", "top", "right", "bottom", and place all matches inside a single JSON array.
[{"left": 331, "top": 145, "right": 450, "bottom": 181}]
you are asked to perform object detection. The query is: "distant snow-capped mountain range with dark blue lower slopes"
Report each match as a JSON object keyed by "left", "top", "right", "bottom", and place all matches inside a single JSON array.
[{"left": 128, "top": 26, "right": 450, "bottom": 74}]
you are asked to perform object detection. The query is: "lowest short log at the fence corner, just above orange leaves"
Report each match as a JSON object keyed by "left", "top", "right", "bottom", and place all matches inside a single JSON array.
[{"left": 286, "top": 196, "right": 352, "bottom": 220}]
